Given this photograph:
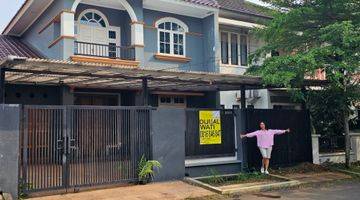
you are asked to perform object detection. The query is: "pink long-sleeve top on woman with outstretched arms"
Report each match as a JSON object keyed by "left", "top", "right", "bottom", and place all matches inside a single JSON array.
[{"left": 246, "top": 129, "right": 286, "bottom": 148}]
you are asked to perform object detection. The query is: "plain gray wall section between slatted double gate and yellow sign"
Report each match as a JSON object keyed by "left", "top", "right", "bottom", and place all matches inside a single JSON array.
[{"left": 151, "top": 108, "right": 186, "bottom": 181}]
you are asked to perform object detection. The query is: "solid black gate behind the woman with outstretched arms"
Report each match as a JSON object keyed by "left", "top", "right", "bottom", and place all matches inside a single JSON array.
[{"left": 245, "top": 109, "right": 312, "bottom": 169}]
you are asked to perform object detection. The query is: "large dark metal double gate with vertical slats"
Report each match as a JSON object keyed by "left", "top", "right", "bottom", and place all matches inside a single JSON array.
[{"left": 20, "top": 106, "right": 150, "bottom": 192}]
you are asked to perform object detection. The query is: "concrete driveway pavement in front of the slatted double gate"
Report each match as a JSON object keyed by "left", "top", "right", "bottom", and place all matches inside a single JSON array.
[{"left": 31, "top": 181, "right": 214, "bottom": 200}]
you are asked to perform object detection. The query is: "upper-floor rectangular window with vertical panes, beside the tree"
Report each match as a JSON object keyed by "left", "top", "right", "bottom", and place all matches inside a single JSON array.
[{"left": 221, "top": 32, "right": 248, "bottom": 66}]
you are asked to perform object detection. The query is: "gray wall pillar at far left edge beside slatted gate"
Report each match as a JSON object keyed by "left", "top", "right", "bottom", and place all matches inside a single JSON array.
[{"left": 0, "top": 104, "right": 20, "bottom": 199}]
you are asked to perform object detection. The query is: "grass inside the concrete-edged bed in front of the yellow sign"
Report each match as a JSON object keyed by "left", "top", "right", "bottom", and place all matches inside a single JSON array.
[{"left": 198, "top": 172, "right": 278, "bottom": 187}]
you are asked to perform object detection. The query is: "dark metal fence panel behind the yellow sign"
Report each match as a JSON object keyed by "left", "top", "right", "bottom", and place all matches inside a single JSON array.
[{"left": 185, "top": 109, "right": 236, "bottom": 159}]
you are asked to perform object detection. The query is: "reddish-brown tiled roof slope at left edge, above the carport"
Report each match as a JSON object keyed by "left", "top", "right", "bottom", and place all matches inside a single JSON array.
[{"left": 0, "top": 35, "right": 41, "bottom": 60}]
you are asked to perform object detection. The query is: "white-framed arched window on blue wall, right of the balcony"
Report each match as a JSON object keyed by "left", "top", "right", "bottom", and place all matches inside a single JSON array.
[{"left": 155, "top": 17, "right": 189, "bottom": 56}]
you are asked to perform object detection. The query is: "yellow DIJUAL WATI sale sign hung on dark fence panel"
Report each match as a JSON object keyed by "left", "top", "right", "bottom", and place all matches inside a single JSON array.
[{"left": 199, "top": 111, "right": 221, "bottom": 145}]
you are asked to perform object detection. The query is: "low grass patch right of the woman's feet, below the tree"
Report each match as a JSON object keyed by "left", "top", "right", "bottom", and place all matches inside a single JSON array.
[{"left": 270, "top": 163, "right": 330, "bottom": 176}]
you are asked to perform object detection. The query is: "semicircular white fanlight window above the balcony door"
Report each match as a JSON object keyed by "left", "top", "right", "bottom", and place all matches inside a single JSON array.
[{"left": 79, "top": 9, "right": 109, "bottom": 28}]
